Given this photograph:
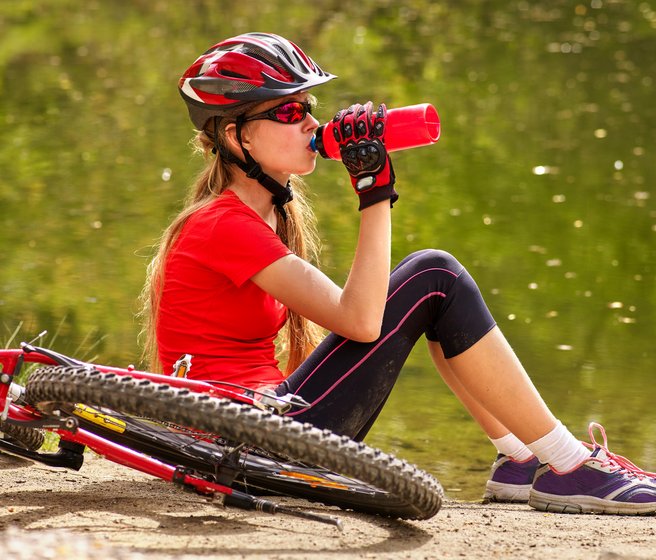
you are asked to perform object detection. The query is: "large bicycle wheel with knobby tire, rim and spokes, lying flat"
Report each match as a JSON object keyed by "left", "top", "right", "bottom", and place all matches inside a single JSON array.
[{"left": 26, "top": 367, "right": 443, "bottom": 519}]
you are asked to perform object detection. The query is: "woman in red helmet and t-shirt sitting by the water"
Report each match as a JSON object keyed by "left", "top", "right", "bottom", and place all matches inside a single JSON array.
[{"left": 140, "top": 33, "right": 656, "bottom": 514}]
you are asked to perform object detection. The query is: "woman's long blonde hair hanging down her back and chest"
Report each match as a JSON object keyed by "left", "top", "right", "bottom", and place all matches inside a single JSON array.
[{"left": 139, "top": 104, "right": 323, "bottom": 375}]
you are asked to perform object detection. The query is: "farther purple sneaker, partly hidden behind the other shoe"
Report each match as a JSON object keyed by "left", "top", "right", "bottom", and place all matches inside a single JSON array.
[{"left": 483, "top": 453, "right": 540, "bottom": 504}]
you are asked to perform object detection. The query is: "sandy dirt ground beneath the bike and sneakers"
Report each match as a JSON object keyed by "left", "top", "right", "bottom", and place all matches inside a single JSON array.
[{"left": 0, "top": 453, "right": 656, "bottom": 560}]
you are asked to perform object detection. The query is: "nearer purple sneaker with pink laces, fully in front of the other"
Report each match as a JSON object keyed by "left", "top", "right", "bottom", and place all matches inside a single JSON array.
[{"left": 528, "top": 422, "right": 656, "bottom": 515}]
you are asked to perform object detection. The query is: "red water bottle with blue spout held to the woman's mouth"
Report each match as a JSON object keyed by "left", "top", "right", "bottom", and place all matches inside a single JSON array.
[{"left": 310, "top": 103, "right": 440, "bottom": 160}]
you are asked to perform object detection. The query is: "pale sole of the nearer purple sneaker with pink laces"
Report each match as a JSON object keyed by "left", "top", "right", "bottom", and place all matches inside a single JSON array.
[{"left": 528, "top": 490, "right": 656, "bottom": 515}]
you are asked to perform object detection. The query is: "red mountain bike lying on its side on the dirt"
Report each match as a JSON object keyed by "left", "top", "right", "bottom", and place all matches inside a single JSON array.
[{"left": 0, "top": 343, "right": 443, "bottom": 528}]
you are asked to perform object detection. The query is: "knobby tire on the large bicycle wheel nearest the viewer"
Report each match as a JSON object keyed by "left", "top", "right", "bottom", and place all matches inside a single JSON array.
[{"left": 26, "top": 367, "right": 443, "bottom": 519}]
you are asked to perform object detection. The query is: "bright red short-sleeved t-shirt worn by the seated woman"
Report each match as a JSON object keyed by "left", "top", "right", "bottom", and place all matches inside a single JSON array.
[{"left": 157, "top": 191, "right": 291, "bottom": 388}]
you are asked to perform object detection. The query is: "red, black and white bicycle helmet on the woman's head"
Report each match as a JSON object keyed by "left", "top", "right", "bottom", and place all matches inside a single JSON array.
[{"left": 178, "top": 33, "right": 336, "bottom": 130}]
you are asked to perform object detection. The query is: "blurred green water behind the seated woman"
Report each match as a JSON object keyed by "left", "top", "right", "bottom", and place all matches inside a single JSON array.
[{"left": 0, "top": 0, "right": 656, "bottom": 499}]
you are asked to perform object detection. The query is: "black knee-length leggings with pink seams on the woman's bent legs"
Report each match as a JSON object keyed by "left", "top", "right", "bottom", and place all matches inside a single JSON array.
[{"left": 276, "top": 249, "right": 495, "bottom": 440}]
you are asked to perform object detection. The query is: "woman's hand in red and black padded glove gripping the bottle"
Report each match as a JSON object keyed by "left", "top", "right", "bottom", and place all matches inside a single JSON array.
[{"left": 333, "top": 101, "right": 399, "bottom": 210}]
